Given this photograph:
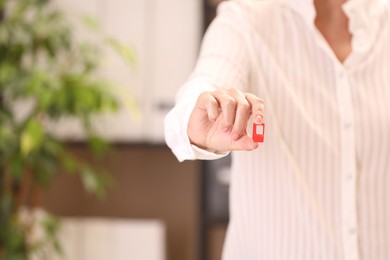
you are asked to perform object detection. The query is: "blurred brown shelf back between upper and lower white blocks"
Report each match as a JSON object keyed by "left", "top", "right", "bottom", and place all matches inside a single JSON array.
[{"left": 42, "top": 144, "right": 201, "bottom": 260}]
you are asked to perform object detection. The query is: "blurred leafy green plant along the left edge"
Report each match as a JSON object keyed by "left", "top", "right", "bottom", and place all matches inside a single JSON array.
[{"left": 0, "top": 0, "right": 134, "bottom": 260}]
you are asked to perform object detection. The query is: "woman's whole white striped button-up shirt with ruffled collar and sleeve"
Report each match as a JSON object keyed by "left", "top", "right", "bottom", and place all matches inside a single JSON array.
[{"left": 165, "top": 0, "right": 390, "bottom": 260}]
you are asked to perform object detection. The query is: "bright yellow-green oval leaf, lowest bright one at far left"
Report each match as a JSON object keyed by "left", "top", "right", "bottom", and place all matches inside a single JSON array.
[{"left": 20, "top": 119, "right": 43, "bottom": 156}]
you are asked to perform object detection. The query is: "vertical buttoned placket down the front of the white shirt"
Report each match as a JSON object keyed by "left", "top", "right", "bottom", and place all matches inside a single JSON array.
[{"left": 337, "top": 68, "right": 360, "bottom": 260}]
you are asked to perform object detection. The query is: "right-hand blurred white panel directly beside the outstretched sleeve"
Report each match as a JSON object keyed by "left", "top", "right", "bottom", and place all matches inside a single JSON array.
[{"left": 147, "top": 0, "right": 201, "bottom": 141}]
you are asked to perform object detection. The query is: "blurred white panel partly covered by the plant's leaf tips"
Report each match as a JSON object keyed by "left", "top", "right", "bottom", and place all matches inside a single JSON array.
[{"left": 99, "top": 0, "right": 150, "bottom": 142}]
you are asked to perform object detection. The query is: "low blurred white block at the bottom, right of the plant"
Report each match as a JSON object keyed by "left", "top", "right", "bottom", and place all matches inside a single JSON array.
[{"left": 52, "top": 218, "right": 166, "bottom": 260}]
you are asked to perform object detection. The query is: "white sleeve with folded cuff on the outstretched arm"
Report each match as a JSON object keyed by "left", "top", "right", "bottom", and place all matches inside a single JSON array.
[{"left": 164, "top": 2, "right": 249, "bottom": 161}]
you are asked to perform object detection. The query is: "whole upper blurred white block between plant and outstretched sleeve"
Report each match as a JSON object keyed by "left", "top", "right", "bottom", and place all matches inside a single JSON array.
[{"left": 51, "top": 0, "right": 202, "bottom": 143}]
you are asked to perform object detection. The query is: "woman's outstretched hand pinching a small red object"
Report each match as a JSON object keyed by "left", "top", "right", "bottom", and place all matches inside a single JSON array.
[{"left": 187, "top": 88, "right": 264, "bottom": 151}]
